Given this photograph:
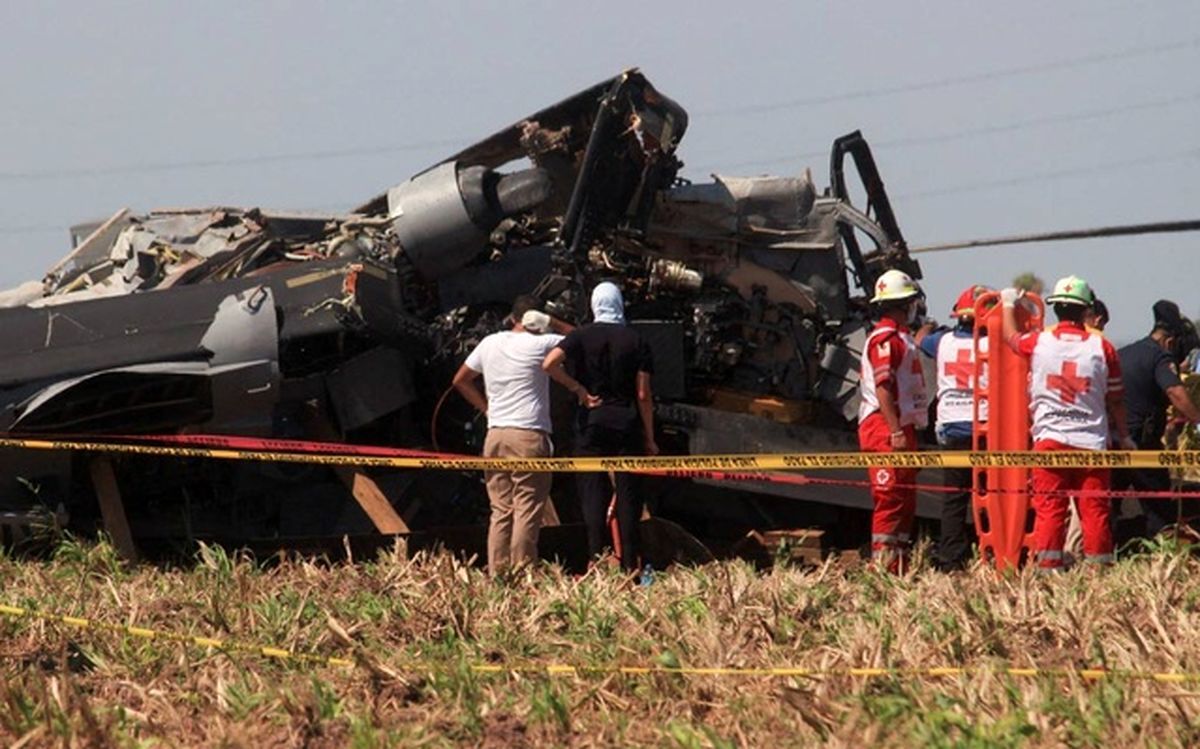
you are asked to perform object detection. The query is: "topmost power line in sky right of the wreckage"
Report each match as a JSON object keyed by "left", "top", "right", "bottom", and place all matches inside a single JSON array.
[{"left": 695, "top": 37, "right": 1200, "bottom": 116}]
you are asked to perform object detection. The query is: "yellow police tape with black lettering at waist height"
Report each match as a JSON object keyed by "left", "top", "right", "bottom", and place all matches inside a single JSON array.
[{"left": 0, "top": 437, "right": 1200, "bottom": 473}]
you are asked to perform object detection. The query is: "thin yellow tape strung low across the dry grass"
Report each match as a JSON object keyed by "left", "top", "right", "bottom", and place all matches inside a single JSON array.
[{"left": 0, "top": 604, "right": 1200, "bottom": 684}]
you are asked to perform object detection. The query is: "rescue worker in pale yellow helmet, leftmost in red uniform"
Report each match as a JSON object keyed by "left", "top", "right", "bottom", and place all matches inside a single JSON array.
[{"left": 858, "top": 270, "right": 929, "bottom": 573}]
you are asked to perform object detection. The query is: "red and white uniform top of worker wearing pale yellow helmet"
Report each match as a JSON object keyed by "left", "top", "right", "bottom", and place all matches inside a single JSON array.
[{"left": 858, "top": 318, "right": 929, "bottom": 429}]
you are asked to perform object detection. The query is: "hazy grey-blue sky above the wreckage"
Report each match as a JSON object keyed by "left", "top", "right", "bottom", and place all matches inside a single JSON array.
[{"left": 0, "top": 0, "right": 1200, "bottom": 341}]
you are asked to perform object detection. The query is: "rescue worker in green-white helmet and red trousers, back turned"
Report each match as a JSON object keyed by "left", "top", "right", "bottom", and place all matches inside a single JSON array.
[{"left": 1001, "top": 276, "right": 1135, "bottom": 570}]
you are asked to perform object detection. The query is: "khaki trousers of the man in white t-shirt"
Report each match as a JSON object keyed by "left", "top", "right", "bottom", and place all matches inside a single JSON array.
[{"left": 484, "top": 426, "right": 553, "bottom": 575}]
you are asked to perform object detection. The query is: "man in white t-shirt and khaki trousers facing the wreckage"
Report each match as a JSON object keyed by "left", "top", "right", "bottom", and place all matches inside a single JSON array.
[{"left": 454, "top": 296, "right": 563, "bottom": 575}]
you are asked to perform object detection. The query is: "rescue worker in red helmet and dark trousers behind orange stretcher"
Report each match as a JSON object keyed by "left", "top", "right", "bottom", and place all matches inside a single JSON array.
[{"left": 920, "top": 286, "right": 991, "bottom": 570}]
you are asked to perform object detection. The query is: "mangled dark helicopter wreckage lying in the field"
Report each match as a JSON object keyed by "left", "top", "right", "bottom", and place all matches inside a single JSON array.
[{"left": 0, "top": 71, "right": 936, "bottom": 561}]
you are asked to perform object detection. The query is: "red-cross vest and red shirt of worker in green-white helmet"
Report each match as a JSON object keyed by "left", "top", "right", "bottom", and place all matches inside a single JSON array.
[{"left": 1016, "top": 323, "right": 1122, "bottom": 450}]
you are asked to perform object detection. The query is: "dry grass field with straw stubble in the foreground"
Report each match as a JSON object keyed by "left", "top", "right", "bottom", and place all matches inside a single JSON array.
[{"left": 0, "top": 541, "right": 1200, "bottom": 748}]
